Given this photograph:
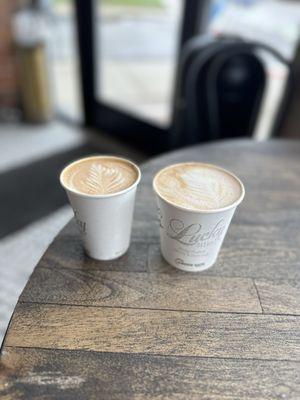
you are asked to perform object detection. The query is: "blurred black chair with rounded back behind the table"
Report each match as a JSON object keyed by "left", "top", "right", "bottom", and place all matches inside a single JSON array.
[{"left": 170, "top": 37, "right": 290, "bottom": 147}]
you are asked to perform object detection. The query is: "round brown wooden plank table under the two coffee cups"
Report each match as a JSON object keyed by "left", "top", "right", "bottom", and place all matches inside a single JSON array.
[{"left": 0, "top": 140, "right": 300, "bottom": 400}]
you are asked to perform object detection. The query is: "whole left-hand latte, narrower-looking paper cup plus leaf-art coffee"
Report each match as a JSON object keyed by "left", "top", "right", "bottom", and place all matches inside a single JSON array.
[{"left": 60, "top": 156, "right": 141, "bottom": 260}]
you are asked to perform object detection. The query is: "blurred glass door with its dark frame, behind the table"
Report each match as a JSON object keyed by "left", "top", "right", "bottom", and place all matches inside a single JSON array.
[{"left": 75, "top": 0, "right": 208, "bottom": 153}]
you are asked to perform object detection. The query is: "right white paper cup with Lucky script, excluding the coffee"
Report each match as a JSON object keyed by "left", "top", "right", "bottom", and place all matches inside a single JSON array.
[{"left": 153, "top": 165, "right": 245, "bottom": 272}]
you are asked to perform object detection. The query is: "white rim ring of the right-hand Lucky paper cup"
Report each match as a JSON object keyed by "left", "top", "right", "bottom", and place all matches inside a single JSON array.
[{"left": 152, "top": 161, "right": 245, "bottom": 214}]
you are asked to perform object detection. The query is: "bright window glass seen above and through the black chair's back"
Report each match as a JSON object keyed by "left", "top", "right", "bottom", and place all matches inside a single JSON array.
[{"left": 208, "top": 0, "right": 300, "bottom": 139}]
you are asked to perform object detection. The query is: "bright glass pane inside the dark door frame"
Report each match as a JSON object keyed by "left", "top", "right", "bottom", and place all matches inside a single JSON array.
[{"left": 94, "top": 0, "right": 182, "bottom": 126}]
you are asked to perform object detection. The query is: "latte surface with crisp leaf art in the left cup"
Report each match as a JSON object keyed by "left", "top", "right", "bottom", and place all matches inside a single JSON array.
[{"left": 61, "top": 156, "right": 139, "bottom": 196}]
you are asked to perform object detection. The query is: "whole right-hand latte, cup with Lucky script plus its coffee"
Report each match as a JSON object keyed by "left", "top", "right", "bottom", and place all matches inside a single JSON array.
[{"left": 153, "top": 162, "right": 245, "bottom": 272}]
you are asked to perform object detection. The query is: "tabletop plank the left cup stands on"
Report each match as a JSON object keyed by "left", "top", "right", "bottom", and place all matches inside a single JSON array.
[{"left": 38, "top": 234, "right": 148, "bottom": 271}]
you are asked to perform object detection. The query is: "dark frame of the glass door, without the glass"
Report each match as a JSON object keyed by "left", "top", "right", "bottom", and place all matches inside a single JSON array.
[{"left": 74, "top": 0, "right": 210, "bottom": 154}]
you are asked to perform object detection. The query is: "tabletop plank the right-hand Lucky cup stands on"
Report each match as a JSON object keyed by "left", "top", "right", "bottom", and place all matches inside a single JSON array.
[{"left": 148, "top": 223, "right": 300, "bottom": 280}]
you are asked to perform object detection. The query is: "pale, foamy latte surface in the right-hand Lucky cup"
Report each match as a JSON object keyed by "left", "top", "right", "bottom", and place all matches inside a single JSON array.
[{"left": 154, "top": 162, "right": 243, "bottom": 211}]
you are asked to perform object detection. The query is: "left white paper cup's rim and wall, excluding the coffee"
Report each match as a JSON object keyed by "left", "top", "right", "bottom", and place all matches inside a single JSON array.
[{"left": 60, "top": 156, "right": 141, "bottom": 260}]
